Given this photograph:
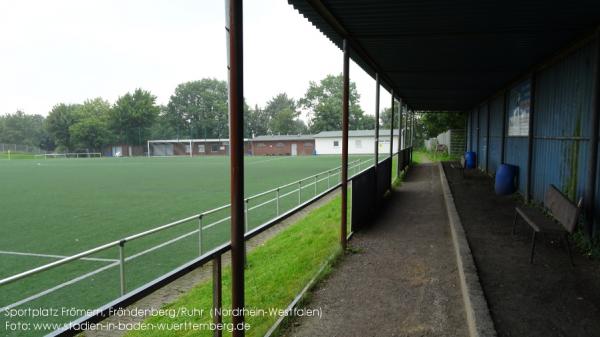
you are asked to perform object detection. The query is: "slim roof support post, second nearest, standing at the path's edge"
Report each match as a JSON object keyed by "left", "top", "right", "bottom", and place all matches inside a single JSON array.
[{"left": 340, "top": 39, "right": 350, "bottom": 250}]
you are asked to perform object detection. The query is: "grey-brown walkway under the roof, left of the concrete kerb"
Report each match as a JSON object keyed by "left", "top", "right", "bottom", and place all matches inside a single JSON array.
[{"left": 287, "top": 164, "right": 468, "bottom": 337}]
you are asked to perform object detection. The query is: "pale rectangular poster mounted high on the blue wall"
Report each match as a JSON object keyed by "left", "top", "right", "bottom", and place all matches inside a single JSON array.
[{"left": 508, "top": 81, "right": 531, "bottom": 136}]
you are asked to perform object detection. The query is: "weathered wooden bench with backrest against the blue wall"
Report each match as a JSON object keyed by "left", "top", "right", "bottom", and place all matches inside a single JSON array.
[{"left": 513, "top": 185, "right": 582, "bottom": 265}]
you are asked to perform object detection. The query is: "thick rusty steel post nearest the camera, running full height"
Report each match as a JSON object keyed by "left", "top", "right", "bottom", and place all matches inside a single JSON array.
[{"left": 225, "top": 0, "right": 245, "bottom": 337}]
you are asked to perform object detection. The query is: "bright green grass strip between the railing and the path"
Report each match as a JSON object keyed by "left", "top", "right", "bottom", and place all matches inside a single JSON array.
[{"left": 126, "top": 193, "right": 341, "bottom": 337}]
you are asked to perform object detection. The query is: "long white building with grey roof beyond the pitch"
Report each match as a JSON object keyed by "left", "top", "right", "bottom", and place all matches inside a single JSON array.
[{"left": 314, "top": 129, "right": 403, "bottom": 154}]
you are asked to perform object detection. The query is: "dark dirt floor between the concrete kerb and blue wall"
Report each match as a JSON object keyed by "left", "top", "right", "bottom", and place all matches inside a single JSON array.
[{"left": 444, "top": 163, "right": 600, "bottom": 337}]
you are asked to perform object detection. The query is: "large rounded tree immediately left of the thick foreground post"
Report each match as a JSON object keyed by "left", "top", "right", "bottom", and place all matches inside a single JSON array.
[{"left": 165, "top": 78, "right": 229, "bottom": 138}]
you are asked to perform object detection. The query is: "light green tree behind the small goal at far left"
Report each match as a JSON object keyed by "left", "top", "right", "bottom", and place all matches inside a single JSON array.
[{"left": 69, "top": 98, "right": 112, "bottom": 151}]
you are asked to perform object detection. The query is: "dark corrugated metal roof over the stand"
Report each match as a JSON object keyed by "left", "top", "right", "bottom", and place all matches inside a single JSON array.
[{"left": 288, "top": 0, "right": 600, "bottom": 111}]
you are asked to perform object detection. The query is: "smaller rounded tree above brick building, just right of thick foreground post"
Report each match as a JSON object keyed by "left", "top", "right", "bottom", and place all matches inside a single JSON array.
[{"left": 264, "top": 93, "right": 307, "bottom": 135}]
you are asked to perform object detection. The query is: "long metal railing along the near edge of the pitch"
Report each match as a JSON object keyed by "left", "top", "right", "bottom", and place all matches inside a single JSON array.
[{"left": 0, "top": 159, "right": 373, "bottom": 334}]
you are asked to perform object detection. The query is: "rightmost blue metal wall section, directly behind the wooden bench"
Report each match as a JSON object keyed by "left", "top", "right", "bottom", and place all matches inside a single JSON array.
[{"left": 532, "top": 46, "right": 593, "bottom": 202}]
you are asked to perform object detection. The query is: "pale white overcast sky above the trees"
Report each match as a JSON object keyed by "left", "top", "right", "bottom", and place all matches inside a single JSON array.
[{"left": 0, "top": 0, "right": 390, "bottom": 119}]
